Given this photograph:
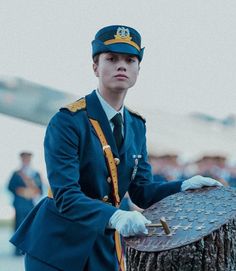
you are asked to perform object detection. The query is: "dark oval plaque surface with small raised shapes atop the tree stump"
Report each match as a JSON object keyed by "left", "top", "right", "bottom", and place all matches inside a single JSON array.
[{"left": 125, "top": 187, "right": 236, "bottom": 252}]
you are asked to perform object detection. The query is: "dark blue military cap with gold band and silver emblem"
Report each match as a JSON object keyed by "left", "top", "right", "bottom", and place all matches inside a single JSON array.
[{"left": 92, "top": 25, "right": 144, "bottom": 61}]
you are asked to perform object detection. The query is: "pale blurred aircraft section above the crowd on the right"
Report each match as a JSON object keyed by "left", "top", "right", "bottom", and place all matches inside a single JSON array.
[{"left": 147, "top": 109, "right": 236, "bottom": 161}]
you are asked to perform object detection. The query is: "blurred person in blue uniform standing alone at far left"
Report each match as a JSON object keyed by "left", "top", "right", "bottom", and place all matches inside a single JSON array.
[{"left": 8, "top": 152, "right": 42, "bottom": 256}]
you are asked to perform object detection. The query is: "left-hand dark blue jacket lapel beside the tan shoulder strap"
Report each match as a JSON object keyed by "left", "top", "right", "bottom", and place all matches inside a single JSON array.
[{"left": 85, "top": 90, "right": 119, "bottom": 157}]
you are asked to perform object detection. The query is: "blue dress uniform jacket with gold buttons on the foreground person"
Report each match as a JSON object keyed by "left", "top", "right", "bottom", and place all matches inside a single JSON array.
[{"left": 11, "top": 91, "right": 181, "bottom": 271}]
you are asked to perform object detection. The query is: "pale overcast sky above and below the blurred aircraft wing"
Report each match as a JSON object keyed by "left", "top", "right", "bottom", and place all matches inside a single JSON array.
[{"left": 0, "top": 0, "right": 236, "bottom": 193}]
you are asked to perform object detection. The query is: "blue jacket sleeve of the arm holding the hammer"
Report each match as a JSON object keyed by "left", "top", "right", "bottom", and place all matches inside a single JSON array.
[{"left": 44, "top": 112, "right": 117, "bottom": 233}]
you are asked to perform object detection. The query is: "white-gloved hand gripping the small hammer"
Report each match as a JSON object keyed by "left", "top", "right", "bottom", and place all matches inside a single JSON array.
[{"left": 109, "top": 210, "right": 151, "bottom": 237}]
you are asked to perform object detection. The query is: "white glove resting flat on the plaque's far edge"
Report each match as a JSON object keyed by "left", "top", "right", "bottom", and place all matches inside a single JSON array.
[{"left": 181, "top": 175, "right": 223, "bottom": 191}]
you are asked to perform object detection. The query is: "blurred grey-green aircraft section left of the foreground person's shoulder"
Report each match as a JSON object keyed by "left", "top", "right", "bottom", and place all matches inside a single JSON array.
[{"left": 0, "top": 77, "right": 76, "bottom": 125}]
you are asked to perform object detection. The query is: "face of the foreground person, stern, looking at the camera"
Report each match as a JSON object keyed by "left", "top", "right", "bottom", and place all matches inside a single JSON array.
[{"left": 93, "top": 53, "right": 139, "bottom": 92}]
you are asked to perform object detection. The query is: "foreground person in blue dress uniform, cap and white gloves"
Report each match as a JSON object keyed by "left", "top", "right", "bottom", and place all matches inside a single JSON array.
[{"left": 11, "top": 25, "right": 222, "bottom": 271}]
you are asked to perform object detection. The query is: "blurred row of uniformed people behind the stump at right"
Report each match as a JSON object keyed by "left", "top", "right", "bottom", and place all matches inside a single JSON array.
[{"left": 121, "top": 154, "right": 236, "bottom": 210}]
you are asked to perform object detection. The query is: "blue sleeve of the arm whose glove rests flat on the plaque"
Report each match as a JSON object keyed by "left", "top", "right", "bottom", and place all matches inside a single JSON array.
[{"left": 129, "top": 125, "right": 182, "bottom": 209}]
